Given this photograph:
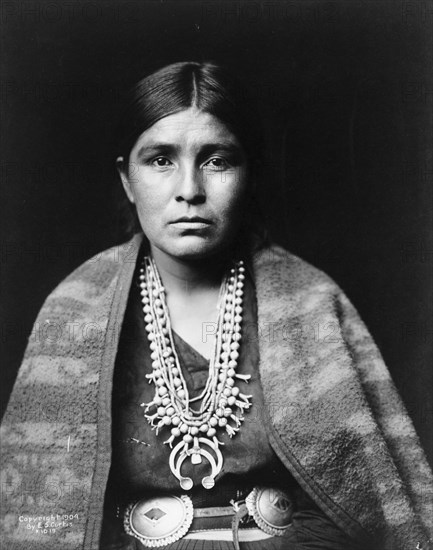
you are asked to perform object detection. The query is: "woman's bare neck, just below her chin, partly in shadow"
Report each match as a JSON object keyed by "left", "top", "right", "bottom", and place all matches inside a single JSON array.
[{"left": 150, "top": 244, "right": 228, "bottom": 295}]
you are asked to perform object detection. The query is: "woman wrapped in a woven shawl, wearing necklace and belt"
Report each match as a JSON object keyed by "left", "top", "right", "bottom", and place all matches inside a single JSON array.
[{"left": 2, "top": 63, "right": 433, "bottom": 550}]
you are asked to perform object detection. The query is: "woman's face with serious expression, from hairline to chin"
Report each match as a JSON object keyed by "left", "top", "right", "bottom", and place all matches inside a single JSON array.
[{"left": 118, "top": 108, "right": 247, "bottom": 259}]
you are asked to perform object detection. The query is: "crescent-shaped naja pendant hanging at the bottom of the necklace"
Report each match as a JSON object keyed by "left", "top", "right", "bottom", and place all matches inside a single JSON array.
[{"left": 169, "top": 437, "right": 224, "bottom": 491}]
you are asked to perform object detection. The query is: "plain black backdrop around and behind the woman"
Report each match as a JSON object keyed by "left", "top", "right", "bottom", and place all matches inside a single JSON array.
[{"left": 0, "top": 0, "right": 433, "bottom": 461}]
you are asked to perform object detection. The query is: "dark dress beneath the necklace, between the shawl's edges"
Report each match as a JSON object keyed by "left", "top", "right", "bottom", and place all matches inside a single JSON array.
[{"left": 100, "top": 251, "right": 356, "bottom": 550}]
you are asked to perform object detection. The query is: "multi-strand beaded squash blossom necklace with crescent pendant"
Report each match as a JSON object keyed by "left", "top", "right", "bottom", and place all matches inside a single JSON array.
[{"left": 140, "top": 256, "right": 252, "bottom": 491}]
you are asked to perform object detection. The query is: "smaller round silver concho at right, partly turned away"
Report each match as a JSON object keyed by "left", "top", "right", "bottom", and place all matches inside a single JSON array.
[{"left": 245, "top": 487, "right": 294, "bottom": 537}]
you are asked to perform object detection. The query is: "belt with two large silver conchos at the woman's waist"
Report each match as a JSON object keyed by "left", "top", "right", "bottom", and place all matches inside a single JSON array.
[{"left": 123, "top": 487, "right": 294, "bottom": 548}]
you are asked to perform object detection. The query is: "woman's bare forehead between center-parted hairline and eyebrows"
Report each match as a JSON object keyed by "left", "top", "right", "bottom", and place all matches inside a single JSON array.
[{"left": 132, "top": 108, "right": 239, "bottom": 152}]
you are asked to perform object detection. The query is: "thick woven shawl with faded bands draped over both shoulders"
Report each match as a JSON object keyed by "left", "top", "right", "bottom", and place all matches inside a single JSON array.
[{"left": 1, "top": 235, "right": 433, "bottom": 550}]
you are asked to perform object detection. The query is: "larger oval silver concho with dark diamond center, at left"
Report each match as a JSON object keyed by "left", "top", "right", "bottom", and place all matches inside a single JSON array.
[{"left": 123, "top": 495, "right": 193, "bottom": 548}]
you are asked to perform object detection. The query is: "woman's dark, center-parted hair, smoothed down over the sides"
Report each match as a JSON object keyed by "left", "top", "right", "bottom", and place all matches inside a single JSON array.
[{"left": 116, "top": 62, "right": 265, "bottom": 250}]
